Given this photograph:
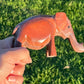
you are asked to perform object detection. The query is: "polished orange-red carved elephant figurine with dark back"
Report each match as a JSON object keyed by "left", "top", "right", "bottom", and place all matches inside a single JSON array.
[{"left": 13, "top": 12, "right": 84, "bottom": 57}]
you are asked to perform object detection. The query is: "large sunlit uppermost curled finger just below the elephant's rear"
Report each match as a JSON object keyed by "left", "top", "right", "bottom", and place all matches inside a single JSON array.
[{"left": 2, "top": 47, "right": 32, "bottom": 65}]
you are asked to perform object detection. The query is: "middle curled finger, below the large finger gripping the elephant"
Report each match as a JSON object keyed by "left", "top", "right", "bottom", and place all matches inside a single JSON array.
[{"left": 10, "top": 65, "right": 25, "bottom": 76}]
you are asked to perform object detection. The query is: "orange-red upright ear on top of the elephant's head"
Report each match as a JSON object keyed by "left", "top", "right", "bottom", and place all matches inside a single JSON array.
[{"left": 55, "top": 12, "right": 68, "bottom": 31}]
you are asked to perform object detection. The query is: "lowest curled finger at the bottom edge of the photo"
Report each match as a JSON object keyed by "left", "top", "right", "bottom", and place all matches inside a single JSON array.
[{"left": 7, "top": 76, "right": 23, "bottom": 84}]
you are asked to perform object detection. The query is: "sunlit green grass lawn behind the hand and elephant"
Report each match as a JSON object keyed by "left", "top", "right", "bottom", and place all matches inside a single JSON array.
[{"left": 0, "top": 0, "right": 84, "bottom": 84}]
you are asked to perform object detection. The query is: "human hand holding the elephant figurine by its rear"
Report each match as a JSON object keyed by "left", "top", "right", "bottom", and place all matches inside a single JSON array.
[{"left": 0, "top": 37, "right": 32, "bottom": 84}]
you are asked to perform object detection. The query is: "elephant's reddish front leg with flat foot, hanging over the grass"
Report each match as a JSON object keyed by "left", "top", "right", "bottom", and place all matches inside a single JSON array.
[{"left": 46, "top": 36, "right": 57, "bottom": 57}]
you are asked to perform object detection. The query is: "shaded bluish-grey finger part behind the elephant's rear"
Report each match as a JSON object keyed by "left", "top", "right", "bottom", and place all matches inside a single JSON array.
[{"left": 0, "top": 36, "right": 14, "bottom": 49}]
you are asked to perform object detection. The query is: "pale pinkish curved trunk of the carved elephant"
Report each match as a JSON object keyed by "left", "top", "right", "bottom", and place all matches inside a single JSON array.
[{"left": 69, "top": 33, "right": 84, "bottom": 53}]
